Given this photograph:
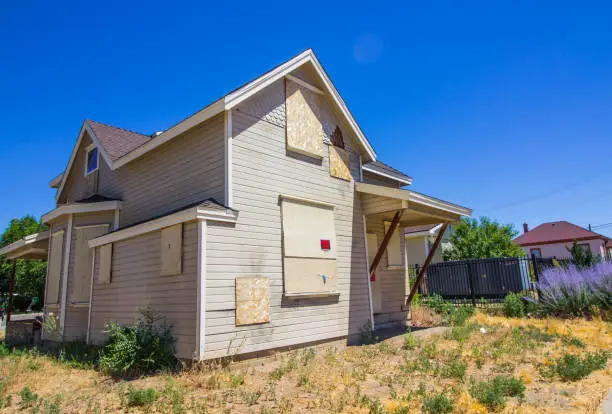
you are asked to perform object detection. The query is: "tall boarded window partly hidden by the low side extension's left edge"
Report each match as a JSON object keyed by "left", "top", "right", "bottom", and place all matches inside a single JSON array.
[{"left": 70, "top": 224, "right": 108, "bottom": 303}]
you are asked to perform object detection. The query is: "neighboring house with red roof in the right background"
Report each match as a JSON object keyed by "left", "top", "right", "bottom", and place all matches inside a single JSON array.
[{"left": 513, "top": 221, "right": 612, "bottom": 258}]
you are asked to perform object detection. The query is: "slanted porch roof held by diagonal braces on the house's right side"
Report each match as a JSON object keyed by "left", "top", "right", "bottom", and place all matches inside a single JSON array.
[{"left": 355, "top": 183, "right": 472, "bottom": 227}]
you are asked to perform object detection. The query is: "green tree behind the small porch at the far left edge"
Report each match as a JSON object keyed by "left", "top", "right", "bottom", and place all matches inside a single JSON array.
[{"left": 0, "top": 215, "right": 47, "bottom": 305}]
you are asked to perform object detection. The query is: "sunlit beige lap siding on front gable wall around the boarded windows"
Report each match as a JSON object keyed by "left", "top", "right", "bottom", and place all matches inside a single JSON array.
[{"left": 205, "top": 94, "right": 369, "bottom": 358}]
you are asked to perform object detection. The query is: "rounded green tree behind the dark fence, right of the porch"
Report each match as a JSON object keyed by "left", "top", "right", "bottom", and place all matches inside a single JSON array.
[{"left": 443, "top": 217, "right": 525, "bottom": 260}]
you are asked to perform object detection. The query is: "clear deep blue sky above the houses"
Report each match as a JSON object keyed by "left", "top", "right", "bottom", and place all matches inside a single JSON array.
[{"left": 0, "top": 1, "right": 612, "bottom": 236}]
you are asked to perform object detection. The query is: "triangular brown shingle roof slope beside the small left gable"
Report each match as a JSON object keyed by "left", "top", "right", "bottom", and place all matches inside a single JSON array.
[{"left": 85, "top": 119, "right": 153, "bottom": 161}]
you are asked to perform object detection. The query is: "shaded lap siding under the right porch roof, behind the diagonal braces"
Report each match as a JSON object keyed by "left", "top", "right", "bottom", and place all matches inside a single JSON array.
[{"left": 366, "top": 218, "right": 406, "bottom": 323}]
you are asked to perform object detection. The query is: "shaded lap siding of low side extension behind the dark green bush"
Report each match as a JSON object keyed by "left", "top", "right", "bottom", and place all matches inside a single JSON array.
[{"left": 91, "top": 222, "right": 198, "bottom": 359}]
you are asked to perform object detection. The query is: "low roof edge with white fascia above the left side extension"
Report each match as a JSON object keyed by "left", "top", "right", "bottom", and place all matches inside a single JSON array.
[{"left": 89, "top": 206, "right": 238, "bottom": 248}]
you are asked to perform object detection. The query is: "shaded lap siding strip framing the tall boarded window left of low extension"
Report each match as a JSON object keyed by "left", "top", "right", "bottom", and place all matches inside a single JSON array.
[{"left": 64, "top": 212, "right": 113, "bottom": 341}]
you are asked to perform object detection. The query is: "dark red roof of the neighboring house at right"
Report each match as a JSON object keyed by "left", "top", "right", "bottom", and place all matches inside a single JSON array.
[{"left": 514, "top": 221, "right": 608, "bottom": 246}]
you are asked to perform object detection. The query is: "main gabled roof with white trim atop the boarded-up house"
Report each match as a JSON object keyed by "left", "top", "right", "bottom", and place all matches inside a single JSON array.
[{"left": 56, "top": 49, "right": 376, "bottom": 200}]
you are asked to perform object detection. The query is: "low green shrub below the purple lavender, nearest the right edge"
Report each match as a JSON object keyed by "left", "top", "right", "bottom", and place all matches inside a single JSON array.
[{"left": 541, "top": 351, "right": 610, "bottom": 381}]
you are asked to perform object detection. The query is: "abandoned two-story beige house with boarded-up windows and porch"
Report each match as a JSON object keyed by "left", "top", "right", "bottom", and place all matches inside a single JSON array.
[{"left": 0, "top": 50, "right": 471, "bottom": 360}]
